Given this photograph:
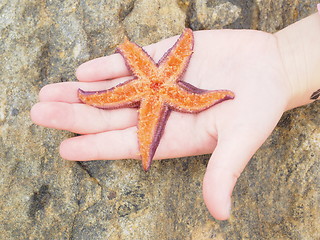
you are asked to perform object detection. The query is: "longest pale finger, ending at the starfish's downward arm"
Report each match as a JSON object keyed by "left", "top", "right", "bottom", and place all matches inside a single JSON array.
[{"left": 31, "top": 102, "right": 137, "bottom": 134}]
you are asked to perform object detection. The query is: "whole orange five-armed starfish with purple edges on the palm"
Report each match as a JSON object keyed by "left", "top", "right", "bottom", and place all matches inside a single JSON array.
[{"left": 78, "top": 29, "right": 234, "bottom": 171}]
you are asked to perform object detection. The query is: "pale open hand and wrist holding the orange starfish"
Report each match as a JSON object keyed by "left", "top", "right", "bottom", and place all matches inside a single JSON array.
[{"left": 31, "top": 14, "right": 320, "bottom": 220}]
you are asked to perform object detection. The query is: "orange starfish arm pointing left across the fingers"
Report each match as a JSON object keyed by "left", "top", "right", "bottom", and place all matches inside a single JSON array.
[{"left": 78, "top": 79, "right": 142, "bottom": 109}]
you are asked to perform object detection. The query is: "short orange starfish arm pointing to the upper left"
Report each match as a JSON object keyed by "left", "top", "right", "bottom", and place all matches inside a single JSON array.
[{"left": 117, "top": 39, "right": 157, "bottom": 77}]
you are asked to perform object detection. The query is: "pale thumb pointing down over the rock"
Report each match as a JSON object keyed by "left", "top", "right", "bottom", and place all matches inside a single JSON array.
[{"left": 203, "top": 128, "right": 263, "bottom": 220}]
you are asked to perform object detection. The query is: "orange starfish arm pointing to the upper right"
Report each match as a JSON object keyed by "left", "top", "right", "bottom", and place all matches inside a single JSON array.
[{"left": 158, "top": 28, "right": 194, "bottom": 82}]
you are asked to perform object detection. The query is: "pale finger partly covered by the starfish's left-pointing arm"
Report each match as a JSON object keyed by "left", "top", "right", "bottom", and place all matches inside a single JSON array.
[{"left": 39, "top": 77, "right": 132, "bottom": 103}]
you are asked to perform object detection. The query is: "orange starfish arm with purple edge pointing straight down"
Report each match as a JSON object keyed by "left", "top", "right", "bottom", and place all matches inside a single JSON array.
[{"left": 138, "top": 96, "right": 170, "bottom": 171}]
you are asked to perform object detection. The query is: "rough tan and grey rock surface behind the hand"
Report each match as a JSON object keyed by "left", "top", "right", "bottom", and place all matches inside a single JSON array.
[{"left": 0, "top": 0, "right": 320, "bottom": 240}]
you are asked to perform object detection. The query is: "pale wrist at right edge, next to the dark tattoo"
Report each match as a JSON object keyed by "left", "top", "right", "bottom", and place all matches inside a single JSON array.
[{"left": 274, "top": 14, "right": 320, "bottom": 110}]
